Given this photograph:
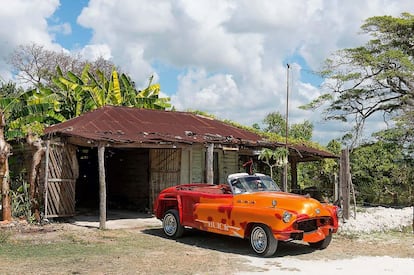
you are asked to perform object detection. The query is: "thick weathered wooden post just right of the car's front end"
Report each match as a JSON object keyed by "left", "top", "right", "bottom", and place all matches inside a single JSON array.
[{"left": 339, "top": 149, "right": 351, "bottom": 219}]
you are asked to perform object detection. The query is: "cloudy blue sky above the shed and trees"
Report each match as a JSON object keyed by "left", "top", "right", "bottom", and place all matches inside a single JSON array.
[{"left": 0, "top": 0, "right": 414, "bottom": 144}]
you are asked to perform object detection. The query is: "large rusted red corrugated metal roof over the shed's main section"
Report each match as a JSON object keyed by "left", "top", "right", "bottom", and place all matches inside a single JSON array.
[{"left": 45, "top": 106, "right": 266, "bottom": 145}]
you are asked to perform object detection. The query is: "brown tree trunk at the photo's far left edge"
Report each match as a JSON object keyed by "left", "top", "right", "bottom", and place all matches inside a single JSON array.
[{"left": 0, "top": 111, "right": 12, "bottom": 221}]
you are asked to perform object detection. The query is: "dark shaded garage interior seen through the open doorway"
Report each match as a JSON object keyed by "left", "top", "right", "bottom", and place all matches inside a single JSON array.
[{"left": 75, "top": 147, "right": 150, "bottom": 212}]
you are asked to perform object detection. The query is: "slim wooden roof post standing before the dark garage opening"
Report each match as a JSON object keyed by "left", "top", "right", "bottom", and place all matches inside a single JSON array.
[{"left": 98, "top": 143, "right": 106, "bottom": 229}]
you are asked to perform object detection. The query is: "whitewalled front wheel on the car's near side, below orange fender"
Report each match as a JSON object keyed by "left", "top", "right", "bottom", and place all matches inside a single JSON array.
[{"left": 250, "top": 224, "right": 277, "bottom": 257}]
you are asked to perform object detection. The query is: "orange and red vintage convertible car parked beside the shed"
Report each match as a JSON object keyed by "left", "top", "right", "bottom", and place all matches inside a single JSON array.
[{"left": 154, "top": 173, "right": 341, "bottom": 257}]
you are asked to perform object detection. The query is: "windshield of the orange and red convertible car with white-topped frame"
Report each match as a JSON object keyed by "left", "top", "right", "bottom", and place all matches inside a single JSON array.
[{"left": 230, "top": 176, "right": 281, "bottom": 194}]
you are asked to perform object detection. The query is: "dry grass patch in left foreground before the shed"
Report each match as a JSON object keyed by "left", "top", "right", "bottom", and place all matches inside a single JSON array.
[{"left": 0, "top": 230, "right": 240, "bottom": 274}]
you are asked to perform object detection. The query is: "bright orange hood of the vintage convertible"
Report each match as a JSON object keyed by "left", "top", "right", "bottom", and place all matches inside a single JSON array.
[{"left": 234, "top": 192, "right": 330, "bottom": 217}]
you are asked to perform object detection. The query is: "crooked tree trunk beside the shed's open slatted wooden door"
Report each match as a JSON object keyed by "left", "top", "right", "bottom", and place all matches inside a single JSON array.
[{"left": 27, "top": 134, "right": 46, "bottom": 222}]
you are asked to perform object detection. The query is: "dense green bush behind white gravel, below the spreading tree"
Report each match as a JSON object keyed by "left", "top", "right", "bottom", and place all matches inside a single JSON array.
[{"left": 350, "top": 140, "right": 414, "bottom": 205}]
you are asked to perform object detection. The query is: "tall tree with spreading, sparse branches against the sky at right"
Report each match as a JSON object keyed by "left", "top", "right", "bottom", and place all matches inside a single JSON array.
[{"left": 304, "top": 13, "right": 414, "bottom": 147}]
